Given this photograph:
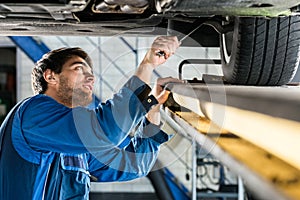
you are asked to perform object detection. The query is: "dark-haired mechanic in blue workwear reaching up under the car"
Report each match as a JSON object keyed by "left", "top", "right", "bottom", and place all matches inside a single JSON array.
[{"left": 0, "top": 36, "right": 179, "bottom": 200}]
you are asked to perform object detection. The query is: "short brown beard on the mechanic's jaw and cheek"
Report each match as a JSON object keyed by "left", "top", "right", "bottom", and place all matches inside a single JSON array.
[{"left": 57, "top": 76, "right": 93, "bottom": 107}]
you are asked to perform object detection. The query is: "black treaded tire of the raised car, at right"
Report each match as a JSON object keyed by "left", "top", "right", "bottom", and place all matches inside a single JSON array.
[{"left": 221, "top": 16, "right": 300, "bottom": 86}]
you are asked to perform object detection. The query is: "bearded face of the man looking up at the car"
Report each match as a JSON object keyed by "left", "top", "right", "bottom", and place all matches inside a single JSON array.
[{"left": 57, "top": 56, "right": 95, "bottom": 107}]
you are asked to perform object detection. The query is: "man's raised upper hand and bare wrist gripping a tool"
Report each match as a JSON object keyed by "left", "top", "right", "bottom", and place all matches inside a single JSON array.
[{"left": 135, "top": 36, "right": 180, "bottom": 84}]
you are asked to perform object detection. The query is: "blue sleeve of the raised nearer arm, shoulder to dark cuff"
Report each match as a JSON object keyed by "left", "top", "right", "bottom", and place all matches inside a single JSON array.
[{"left": 14, "top": 76, "right": 157, "bottom": 154}]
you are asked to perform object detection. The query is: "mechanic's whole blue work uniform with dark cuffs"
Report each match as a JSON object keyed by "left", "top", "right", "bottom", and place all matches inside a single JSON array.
[{"left": 0, "top": 76, "right": 170, "bottom": 200}]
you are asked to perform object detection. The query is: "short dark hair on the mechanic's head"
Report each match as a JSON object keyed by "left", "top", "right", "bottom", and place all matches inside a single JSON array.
[{"left": 31, "top": 47, "right": 92, "bottom": 94}]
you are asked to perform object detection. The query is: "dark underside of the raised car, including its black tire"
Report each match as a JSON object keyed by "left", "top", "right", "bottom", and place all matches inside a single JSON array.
[{"left": 0, "top": 0, "right": 300, "bottom": 85}]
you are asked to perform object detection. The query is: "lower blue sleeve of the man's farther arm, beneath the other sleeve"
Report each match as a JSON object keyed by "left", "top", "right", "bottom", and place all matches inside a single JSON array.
[{"left": 89, "top": 118, "right": 171, "bottom": 182}]
